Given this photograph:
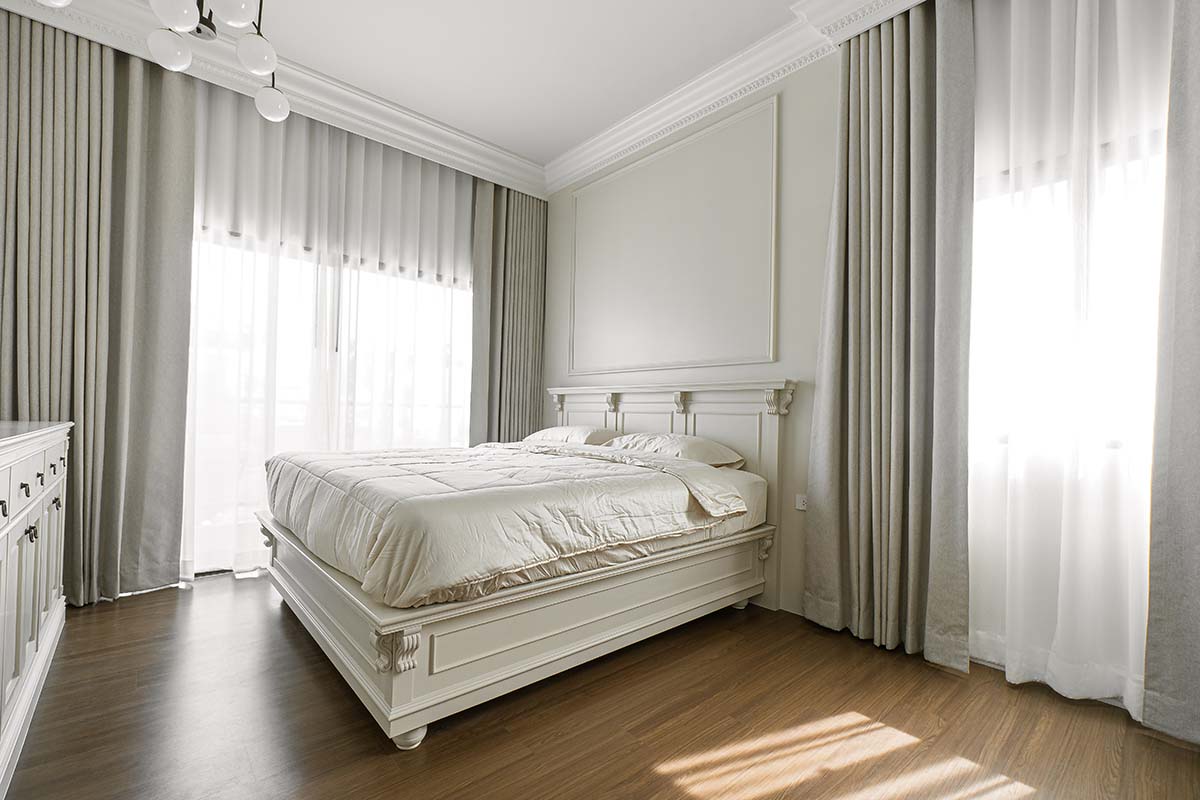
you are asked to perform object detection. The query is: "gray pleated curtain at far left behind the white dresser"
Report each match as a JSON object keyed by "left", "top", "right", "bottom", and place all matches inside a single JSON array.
[{"left": 0, "top": 12, "right": 194, "bottom": 604}]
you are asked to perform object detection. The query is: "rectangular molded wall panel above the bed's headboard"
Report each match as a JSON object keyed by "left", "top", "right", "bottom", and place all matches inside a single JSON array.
[{"left": 568, "top": 95, "right": 779, "bottom": 375}]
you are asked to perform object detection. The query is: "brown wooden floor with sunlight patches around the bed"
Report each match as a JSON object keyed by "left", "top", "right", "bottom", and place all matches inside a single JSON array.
[{"left": 8, "top": 577, "right": 1200, "bottom": 800}]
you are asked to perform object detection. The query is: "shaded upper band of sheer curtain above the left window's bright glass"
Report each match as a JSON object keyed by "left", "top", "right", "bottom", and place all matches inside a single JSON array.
[{"left": 196, "top": 84, "right": 474, "bottom": 289}]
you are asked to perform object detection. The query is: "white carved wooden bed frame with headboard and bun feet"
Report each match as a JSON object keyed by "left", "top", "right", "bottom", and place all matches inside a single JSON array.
[{"left": 259, "top": 380, "right": 793, "bottom": 750}]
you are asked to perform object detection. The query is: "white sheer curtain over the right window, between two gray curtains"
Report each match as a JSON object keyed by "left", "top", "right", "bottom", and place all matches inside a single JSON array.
[{"left": 970, "top": 0, "right": 1171, "bottom": 718}]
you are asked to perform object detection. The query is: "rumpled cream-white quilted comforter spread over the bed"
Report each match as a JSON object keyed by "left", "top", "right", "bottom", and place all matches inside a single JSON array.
[{"left": 266, "top": 444, "right": 746, "bottom": 608}]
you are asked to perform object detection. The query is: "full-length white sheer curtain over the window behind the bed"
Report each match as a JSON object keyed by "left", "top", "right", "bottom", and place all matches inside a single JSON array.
[{"left": 181, "top": 84, "right": 473, "bottom": 577}]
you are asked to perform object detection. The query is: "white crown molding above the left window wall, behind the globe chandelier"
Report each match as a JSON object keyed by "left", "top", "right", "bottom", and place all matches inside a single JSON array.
[{"left": 0, "top": 0, "right": 546, "bottom": 198}]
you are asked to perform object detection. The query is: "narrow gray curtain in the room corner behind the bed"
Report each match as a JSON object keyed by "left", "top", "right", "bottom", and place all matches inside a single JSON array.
[{"left": 470, "top": 180, "right": 547, "bottom": 444}]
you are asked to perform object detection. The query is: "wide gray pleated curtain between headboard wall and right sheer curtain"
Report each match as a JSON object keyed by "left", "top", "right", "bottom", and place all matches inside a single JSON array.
[{"left": 804, "top": 0, "right": 974, "bottom": 669}]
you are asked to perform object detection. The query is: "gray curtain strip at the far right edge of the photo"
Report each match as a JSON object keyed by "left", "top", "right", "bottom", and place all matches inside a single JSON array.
[{"left": 1144, "top": 0, "right": 1200, "bottom": 742}]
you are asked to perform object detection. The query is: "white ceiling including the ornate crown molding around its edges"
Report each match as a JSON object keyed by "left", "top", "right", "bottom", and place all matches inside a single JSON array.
[{"left": 7, "top": 0, "right": 902, "bottom": 198}]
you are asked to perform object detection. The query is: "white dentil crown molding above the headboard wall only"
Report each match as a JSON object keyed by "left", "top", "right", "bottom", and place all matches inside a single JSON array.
[{"left": 546, "top": 0, "right": 922, "bottom": 193}]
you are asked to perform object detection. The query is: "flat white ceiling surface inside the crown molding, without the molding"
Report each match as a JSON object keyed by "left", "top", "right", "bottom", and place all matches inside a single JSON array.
[{"left": 263, "top": 0, "right": 794, "bottom": 164}]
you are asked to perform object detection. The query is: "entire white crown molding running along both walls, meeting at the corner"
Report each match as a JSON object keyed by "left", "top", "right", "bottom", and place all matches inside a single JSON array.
[{"left": 0, "top": 0, "right": 920, "bottom": 198}]
